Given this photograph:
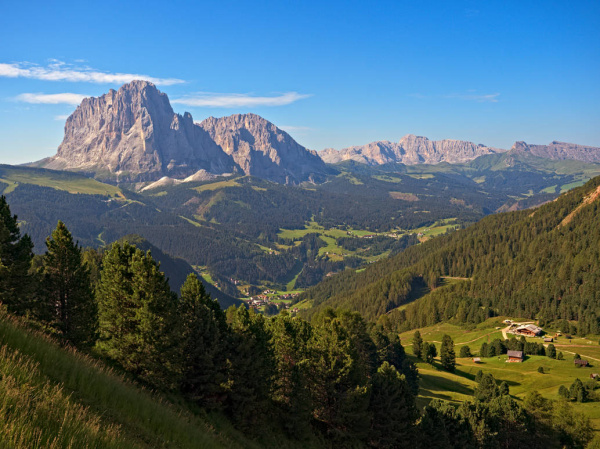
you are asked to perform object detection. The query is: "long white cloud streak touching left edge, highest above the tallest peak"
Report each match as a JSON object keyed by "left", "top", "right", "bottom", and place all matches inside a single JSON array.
[{"left": 0, "top": 60, "right": 185, "bottom": 86}]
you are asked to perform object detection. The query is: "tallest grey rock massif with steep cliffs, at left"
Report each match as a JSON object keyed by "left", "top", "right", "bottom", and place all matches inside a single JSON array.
[{"left": 44, "top": 81, "right": 235, "bottom": 181}]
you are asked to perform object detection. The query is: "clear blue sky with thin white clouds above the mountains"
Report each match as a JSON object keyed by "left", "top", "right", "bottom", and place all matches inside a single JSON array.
[{"left": 0, "top": 1, "right": 600, "bottom": 163}]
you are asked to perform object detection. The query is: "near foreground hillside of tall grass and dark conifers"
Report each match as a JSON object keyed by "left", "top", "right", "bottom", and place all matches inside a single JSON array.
[{"left": 0, "top": 196, "right": 593, "bottom": 449}]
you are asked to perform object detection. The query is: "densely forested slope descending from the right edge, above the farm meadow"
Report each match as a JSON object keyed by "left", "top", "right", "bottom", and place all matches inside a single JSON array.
[{"left": 301, "top": 173, "right": 600, "bottom": 334}]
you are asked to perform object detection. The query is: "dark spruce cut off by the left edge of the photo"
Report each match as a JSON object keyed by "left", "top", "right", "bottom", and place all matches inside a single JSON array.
[{"left": 0, "top": 195, "right": 33, "bottom": 315}]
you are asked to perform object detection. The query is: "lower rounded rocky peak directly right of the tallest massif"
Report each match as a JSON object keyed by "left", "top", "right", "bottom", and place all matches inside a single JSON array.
[{"left": 199, "top": 114, "right": 330, "bottom": 184}]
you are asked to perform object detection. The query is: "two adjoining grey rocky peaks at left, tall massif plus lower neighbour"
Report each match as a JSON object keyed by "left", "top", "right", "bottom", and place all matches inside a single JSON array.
[{"left": 33, "top": 81, "right": 331, "bottom": 184}]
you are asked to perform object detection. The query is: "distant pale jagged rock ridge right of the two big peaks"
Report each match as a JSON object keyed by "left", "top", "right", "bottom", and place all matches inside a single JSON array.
[{"left": 319, "top": 134, "right": 504, "bottom": 165}]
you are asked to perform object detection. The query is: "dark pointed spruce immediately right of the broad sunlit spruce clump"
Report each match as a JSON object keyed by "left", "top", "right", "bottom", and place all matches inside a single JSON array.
[{"left": 178, "top": 273, "right": 228, "bottom": 408}]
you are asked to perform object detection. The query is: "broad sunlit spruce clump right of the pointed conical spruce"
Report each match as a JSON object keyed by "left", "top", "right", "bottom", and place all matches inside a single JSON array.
[{"left": 97, "top": 242, "right": 179, "bottom": 389}]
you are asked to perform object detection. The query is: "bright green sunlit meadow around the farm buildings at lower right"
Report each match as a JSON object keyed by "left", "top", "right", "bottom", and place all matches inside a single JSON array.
[{"left": 400, "top": 317, "right": 600, "bottom": 432}]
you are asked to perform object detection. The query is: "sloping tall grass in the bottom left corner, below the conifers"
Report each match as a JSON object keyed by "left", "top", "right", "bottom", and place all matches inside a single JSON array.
[{"left": 0, "top": 309, "right": 257, "bottom": 449}]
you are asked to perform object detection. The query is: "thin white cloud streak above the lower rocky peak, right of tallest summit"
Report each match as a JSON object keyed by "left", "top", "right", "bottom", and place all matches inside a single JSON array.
[{"left": 171, "top": 92, "right": 311, "bottom": 108}]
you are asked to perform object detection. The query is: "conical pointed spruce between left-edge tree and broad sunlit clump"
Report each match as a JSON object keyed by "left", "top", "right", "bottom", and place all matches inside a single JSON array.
[{"left": 40, "top": 221, "right": 97, "bottom": 346}]
